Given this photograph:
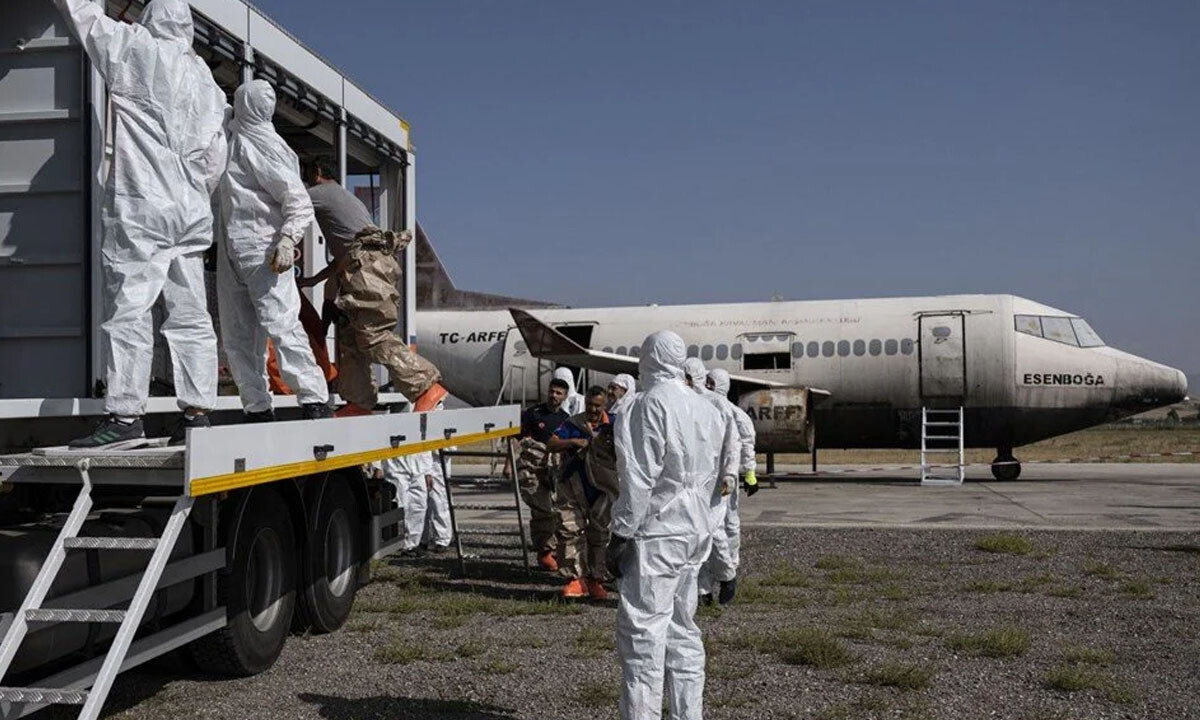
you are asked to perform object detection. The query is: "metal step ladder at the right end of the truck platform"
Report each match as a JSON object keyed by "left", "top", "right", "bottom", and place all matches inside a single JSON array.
[{"left": 438, "top": 440, "right": 533, "bottom": 575}]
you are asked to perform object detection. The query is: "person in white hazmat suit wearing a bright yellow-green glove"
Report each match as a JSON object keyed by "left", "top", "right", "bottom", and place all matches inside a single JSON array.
[{"left": 700, "top": 367, "right": 758, "bottom": 605}]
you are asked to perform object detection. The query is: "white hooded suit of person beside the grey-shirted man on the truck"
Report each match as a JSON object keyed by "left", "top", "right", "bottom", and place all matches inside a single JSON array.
[{"left": 216, "top": 79, "right": 329, "bottom": 413}]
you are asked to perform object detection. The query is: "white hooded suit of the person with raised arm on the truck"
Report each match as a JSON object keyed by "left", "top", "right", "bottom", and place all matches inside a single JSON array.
[{"left": 55, "top": 0, "right": 228, "bottom": 416}]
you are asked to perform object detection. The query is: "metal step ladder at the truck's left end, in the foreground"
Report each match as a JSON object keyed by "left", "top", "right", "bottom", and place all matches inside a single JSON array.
[{"left": 0, "top": 458, "right": 193, "bottom": 720}]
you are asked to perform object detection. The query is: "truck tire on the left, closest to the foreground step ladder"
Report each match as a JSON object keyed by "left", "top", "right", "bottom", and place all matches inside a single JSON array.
[{"left": 188, "top": 487, "right": 296, "bottom": 677}]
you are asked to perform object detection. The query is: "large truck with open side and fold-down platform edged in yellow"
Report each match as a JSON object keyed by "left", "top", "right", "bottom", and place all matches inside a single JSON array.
[{"left": 0, "top": 0, "right": 520, "bottom": 719}]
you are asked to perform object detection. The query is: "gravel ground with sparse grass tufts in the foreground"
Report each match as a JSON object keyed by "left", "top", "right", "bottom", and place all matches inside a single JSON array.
[{"left": 51, "top": 528, "right": 1200, "bottom": 720}]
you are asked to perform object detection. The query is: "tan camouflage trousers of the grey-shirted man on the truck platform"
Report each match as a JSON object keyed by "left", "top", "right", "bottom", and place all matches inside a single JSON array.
[{"left": 335, "top": 227, "right": 442, "bottom": 408}]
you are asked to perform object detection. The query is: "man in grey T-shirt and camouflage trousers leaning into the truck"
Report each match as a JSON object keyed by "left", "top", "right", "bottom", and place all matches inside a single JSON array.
[{"left": 299, "top": 163, "right": 446, "bottom": 416}]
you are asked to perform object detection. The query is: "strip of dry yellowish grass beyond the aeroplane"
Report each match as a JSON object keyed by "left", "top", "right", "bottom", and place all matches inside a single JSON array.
[{"left": 775, "top": 426, "right": 1200, "bottom": 466}]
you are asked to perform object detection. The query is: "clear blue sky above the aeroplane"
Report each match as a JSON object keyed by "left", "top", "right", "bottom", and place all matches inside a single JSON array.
[{"left": 256, "top": 0, "right": 1200, "bottom": 379}]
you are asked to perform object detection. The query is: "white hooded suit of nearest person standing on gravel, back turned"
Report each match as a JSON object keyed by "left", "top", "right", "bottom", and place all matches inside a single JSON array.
[{"left": 612, "top": 331, "right": 733, "bottom": 720}]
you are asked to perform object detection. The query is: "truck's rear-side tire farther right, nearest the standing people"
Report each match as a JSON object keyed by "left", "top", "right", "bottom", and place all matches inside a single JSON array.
[{"left": 300, "top": 475, "right": 362, "bottom": 632}]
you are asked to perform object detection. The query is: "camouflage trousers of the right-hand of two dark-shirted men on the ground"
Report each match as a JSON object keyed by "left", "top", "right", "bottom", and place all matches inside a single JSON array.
[{"left": 554, "top": 474, "right": 612, "bottom": 581}]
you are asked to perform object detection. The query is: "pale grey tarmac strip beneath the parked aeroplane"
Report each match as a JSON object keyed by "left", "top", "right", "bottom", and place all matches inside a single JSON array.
[{"left": 456, "top": 463, "right": 1200, "bottom": 530}]
